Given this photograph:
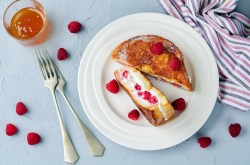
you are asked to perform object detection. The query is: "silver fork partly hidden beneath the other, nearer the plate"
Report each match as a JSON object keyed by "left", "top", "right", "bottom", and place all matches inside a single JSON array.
[{"left": 54, "top": 65, "right": 105, "bottom": 156}]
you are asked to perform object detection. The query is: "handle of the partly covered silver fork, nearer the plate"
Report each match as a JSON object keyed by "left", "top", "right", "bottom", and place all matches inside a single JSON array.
[{"left": 59, "top": 91, "right": 105, "bottom": 156}]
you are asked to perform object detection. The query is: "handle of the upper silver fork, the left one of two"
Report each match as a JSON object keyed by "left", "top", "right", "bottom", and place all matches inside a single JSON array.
[{"left": 51, "top": 90, "right": 78, "bottom": 164}]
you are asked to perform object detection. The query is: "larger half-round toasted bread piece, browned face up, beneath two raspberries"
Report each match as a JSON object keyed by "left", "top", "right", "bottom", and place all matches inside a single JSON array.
[{"left": 112, "top": 35, "right": 192, "bottom": 91}]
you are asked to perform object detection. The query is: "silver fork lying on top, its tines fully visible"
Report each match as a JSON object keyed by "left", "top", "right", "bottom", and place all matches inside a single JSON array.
[{"left": 36, "top": 48, "right": 78, "bottom": 164}]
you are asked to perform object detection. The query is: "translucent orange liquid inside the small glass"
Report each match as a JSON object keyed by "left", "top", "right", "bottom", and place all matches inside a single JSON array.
[{"left": 8, "top": 8, "right": 44, "bottom": 39}]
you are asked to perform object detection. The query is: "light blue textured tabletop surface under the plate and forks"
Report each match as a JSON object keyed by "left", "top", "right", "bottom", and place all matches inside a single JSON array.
[{"left": 0, "top": 0, "right": 250, "bottom": 165}]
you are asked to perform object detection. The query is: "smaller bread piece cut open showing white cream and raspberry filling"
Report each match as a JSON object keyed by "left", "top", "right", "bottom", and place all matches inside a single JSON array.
[{"left": 114, "top": 67, "right": 174, "bottom": 126}]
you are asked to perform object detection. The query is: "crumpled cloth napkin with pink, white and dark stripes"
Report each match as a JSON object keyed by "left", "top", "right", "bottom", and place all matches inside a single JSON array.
[{"left": 159, "top": 0, "right": 250, "bottom": 111}]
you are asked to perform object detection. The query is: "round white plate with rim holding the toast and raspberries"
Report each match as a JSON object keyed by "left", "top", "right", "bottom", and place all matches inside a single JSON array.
[{"left": 78, "top": 13, "right": 219, "bottom": 150}]
